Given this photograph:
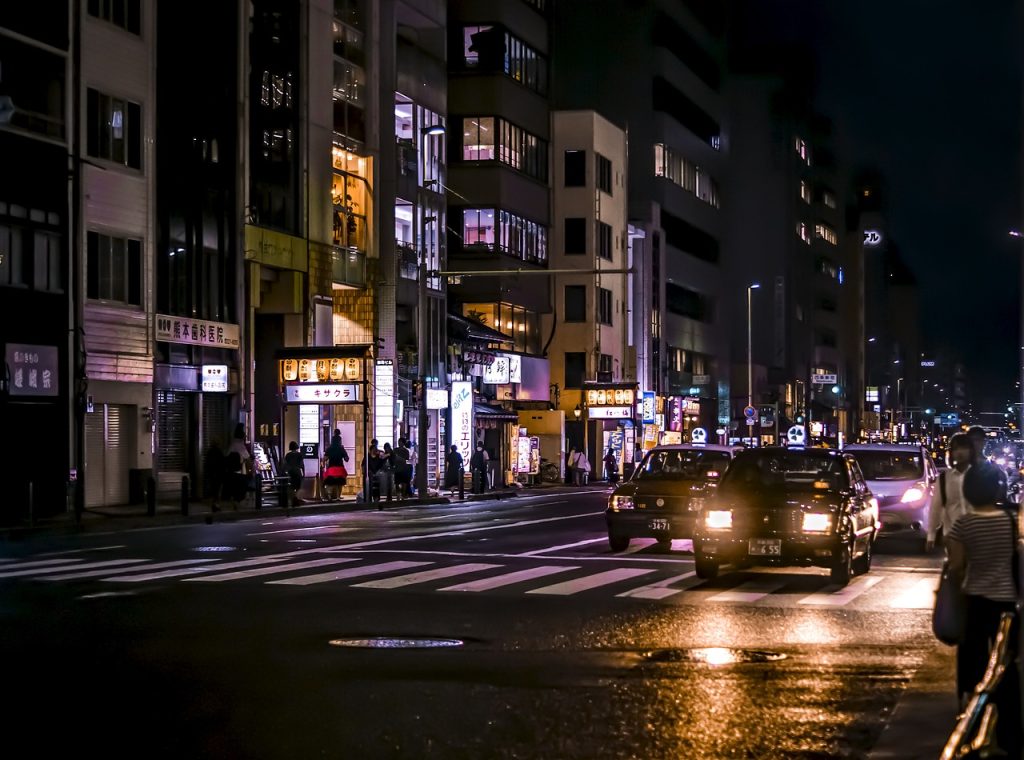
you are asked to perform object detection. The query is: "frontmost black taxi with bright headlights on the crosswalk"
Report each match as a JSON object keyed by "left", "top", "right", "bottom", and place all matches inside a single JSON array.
[{"left": 693, "top": 447, "right": 880, "bottom": 586}]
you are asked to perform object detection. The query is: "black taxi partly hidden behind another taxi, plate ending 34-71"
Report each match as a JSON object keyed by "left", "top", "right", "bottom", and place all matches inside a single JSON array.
[{"left": 605, "top": 444, "right": 739, "bottom": 551}]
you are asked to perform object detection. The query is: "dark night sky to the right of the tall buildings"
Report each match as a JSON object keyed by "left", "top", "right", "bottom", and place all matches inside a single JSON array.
[{"left": 734, "top": 0, "right": 1024, "bottom": 406}]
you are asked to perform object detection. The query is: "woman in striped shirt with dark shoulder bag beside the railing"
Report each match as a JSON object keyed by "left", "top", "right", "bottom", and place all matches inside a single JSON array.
[{"left": 947, "top": 463, "right": 1021, "bottom": 757}]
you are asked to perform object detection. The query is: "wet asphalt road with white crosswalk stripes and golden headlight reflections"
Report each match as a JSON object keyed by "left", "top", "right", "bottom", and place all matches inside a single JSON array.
[{"left": 0, "top": 491, "right": 946, "bottom": 758}]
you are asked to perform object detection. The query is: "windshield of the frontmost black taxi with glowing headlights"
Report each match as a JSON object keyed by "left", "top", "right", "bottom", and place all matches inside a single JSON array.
[{"left": 721, "top": 450, "right": 846, "bottom": 492}]
